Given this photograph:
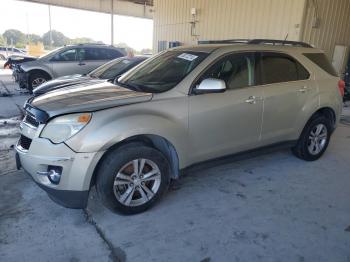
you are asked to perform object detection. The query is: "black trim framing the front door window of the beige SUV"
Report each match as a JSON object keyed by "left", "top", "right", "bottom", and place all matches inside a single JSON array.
[{"left": 188, "top": 50, "right": 259, "bottom": 96}]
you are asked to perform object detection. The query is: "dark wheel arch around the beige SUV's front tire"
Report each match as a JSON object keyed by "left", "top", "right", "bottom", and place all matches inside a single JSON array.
[{"left": 90, "top": 134, "right": 180, "bottom": 188}]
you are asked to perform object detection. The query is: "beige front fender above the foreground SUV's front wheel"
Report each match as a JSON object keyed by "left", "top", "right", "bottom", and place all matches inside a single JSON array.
[{"left": 66, "top": 99, "right": 189, "bottom": 168}]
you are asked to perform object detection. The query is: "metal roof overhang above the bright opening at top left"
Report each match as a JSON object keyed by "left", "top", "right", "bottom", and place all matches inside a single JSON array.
[{"left": 20, "top": 0, "right": 153, "bottom": 19}]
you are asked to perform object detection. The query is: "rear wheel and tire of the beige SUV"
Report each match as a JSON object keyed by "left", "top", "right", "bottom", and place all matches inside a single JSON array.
[{"left": 292, "top": 115, "right": 333, "bottom": 161}]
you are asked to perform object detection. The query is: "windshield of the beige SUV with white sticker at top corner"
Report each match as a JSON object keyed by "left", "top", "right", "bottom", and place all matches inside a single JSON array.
[{"left": 119, "top": 50, "right": 209, "bottom": 93}]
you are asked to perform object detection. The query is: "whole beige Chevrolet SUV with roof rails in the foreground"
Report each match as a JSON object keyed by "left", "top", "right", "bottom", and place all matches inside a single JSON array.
[{"left": 17, "top": 40, "right": 342, "bottom": 214}]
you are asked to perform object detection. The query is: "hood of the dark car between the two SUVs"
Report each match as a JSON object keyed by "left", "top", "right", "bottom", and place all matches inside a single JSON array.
[{"left": 33, "top": 75, "right": 93, "bottom": 96}]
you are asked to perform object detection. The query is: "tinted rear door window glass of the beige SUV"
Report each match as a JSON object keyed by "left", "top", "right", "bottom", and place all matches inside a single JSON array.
[{"left": 259, "top": 53, "right": 310, "bottom": 85}]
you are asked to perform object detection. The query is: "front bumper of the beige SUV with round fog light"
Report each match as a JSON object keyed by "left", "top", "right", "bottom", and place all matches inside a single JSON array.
[{"left": 16, "top": 115, "right": 102, "bottom": 208}]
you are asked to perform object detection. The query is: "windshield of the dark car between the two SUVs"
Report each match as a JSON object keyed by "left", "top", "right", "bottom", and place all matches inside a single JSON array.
[{"left": 89, "top": 58, "right": 143, "bottom": 79}]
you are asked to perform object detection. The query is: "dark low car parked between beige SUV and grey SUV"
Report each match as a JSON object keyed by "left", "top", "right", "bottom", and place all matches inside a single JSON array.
[{"left": 33, "top": 56, "right": 149, "bottom": 96}]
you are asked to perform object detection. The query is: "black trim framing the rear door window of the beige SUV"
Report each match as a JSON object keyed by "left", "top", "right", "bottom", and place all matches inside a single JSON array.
[{"left": 255, "top": 50, "right": 312, "bottom": 86}]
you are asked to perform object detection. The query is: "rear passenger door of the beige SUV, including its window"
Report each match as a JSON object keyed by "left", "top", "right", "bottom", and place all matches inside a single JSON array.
[{"left": 258, "top": 52, "right": 317, "bottom": 144}]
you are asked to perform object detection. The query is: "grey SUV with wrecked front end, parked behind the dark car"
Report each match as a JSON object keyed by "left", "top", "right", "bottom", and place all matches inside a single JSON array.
[{"left": 17, "top": 44, "right": 126, "bottom": 93}]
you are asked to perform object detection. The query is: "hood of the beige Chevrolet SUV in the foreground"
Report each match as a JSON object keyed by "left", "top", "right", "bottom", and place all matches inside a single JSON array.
[{"left": 29, "top": 80, "right": 152, "bottom": 117}]
